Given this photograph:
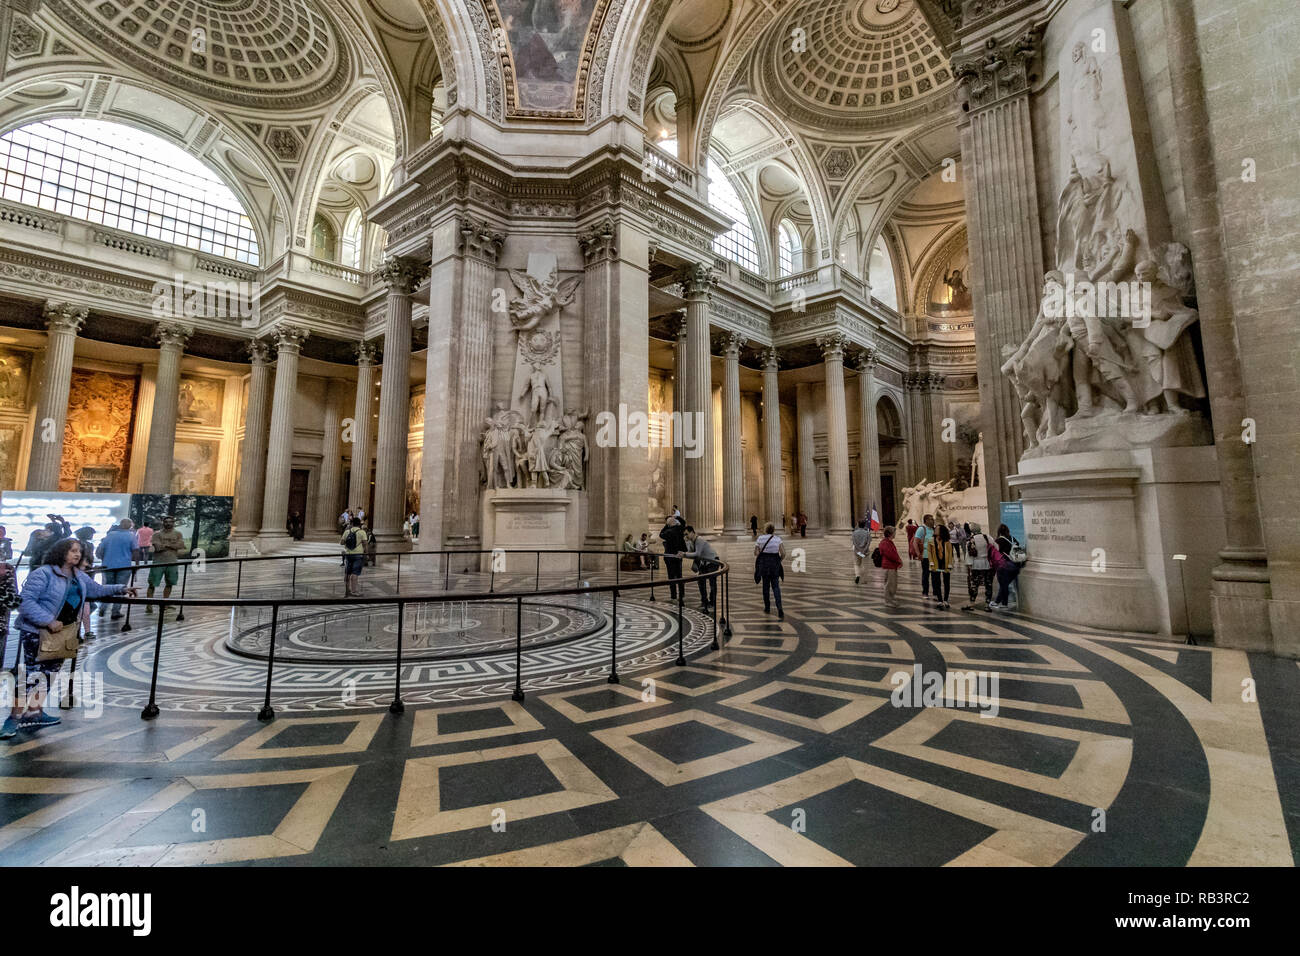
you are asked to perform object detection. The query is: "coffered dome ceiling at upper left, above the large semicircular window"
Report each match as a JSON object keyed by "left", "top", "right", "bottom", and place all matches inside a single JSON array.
[{"left": 49, "top": 0, "right": 351, "bottom": 109}]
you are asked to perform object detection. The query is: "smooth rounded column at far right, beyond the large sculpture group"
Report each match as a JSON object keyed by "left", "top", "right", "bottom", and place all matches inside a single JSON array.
[{"left": 1164, "top": 0, "right": 1268, "bottom": 657}]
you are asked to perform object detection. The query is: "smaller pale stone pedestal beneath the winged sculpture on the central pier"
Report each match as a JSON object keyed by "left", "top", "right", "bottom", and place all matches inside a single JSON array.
[{"left": 480, "top": 488, "right": 586, "bottom": 576}]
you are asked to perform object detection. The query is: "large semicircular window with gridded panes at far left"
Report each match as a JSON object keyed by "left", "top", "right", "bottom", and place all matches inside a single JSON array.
[{"left": 0, "top": 120, "right": 260, "bottom": 265}]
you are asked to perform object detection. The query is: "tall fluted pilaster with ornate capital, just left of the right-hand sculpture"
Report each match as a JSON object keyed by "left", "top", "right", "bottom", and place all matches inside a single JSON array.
[{"left": 956, "top": 29, "right": 1056, "bottom": 515}]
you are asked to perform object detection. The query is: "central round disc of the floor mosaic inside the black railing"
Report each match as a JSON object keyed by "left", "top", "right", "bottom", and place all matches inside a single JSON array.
[{"left": 226, "top": 601, "right": 608, "bottom": 663}]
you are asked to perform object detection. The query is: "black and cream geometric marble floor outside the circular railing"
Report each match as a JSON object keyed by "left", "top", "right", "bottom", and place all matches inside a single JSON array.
[{"left": 0, "top": 541, "right": 1300, "bottom": 866}]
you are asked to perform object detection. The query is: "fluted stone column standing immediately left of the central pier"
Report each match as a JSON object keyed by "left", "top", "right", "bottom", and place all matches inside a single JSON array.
[{"left": 371, "top": 258, "right": 426, "bottom": 549}]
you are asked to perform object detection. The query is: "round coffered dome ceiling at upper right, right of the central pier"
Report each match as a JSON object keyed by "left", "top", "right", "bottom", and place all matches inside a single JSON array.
[{"left": 759, "top": 0, "right": 953, "bottom": 129}]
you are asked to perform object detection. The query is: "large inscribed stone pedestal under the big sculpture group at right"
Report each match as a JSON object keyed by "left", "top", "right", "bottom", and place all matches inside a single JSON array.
[{"left": 1008, "top": 445, "right": 1223, "bottom": 637}]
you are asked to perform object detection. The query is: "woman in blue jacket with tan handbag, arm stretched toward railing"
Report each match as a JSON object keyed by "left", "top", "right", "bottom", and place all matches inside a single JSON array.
[{"left": 0, "top": 537, "right": 135, "bottom": 739}]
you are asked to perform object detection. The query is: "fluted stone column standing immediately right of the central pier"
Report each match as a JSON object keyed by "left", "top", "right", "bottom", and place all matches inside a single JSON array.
[{"left": 677, "top": 263, "right": 716, "bottom": 528}]
